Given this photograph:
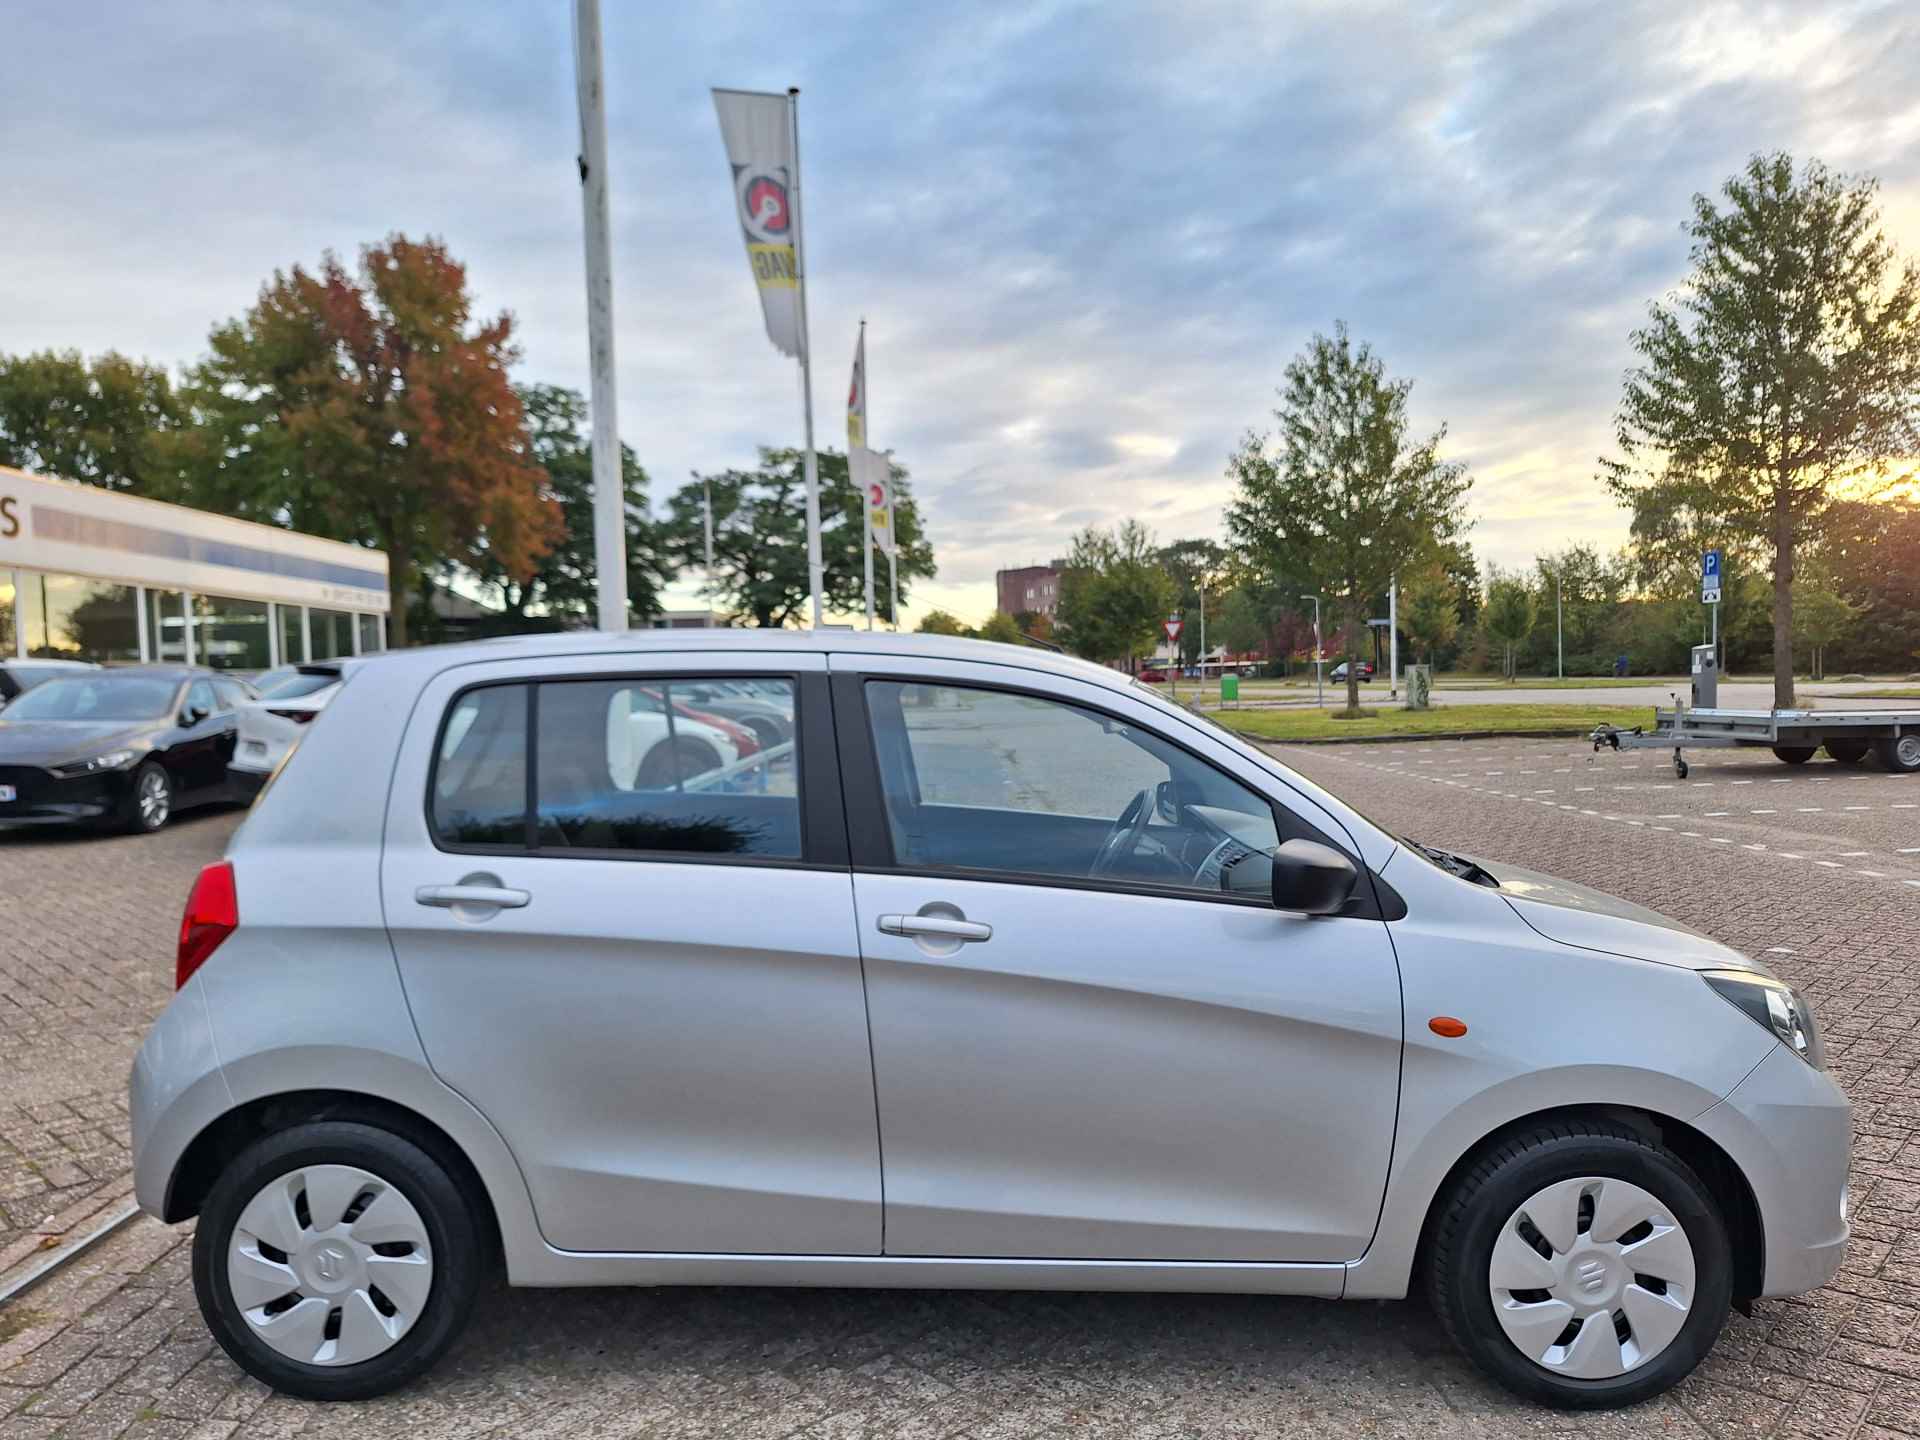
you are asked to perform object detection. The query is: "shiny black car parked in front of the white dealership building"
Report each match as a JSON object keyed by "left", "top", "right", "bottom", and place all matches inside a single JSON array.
[{"left": 0, "top": 664, "right": 253, "bottom": 833}]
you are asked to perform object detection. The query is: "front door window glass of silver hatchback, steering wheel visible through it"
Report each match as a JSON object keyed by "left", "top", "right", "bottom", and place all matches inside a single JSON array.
[{"left": 868, "top": 680, "right": 1282, "bottom": 893}]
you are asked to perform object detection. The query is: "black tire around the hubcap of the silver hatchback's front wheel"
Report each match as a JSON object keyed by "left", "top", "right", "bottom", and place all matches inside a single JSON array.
[{"left": 1425, "top": 1119, "right": 1734, "bottom": 1409}]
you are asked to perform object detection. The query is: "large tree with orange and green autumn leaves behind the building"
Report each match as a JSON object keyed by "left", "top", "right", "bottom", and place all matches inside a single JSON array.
[{"left": 171, "top": 234, "right": 564, "bottom": 645}]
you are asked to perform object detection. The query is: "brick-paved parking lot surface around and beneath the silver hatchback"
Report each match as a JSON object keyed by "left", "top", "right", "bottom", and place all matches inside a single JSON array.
[{"left": 0, "top": 741, "right": 1920, "bottom": 1440}]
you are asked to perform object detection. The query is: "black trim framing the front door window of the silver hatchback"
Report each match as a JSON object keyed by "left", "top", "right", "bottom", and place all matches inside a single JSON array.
[{"left": 833, "top": 670, "right": 1405, "bottom": 920}]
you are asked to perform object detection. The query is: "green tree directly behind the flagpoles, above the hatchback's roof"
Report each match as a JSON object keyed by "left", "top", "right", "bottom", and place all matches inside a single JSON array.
[{"left": 660, "top": 447, "right": 933, "bottom": 626}]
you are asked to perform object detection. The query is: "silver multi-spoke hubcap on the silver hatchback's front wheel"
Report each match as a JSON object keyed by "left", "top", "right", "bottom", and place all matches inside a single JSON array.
[{"left": 1488, "top": 1175, "right": 1693, "bottom": 1380}]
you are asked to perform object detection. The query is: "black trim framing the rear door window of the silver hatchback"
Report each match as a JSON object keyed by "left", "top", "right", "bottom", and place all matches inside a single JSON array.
[{"left": 422, "top": 664, "right": 849, "bottom": 872}]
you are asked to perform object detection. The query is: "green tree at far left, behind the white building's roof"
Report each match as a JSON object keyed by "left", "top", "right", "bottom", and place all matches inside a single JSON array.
[{"left": 0, "top": 349, "right": 182, "bottom": 497}]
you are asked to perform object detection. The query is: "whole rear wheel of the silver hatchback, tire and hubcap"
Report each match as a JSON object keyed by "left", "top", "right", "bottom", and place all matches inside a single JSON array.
[{"left": 194, "top": 1121, "right": 482, "bottom": 1400}]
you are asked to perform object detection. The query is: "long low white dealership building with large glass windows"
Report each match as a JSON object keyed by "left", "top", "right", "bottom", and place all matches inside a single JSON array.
[{"left": 0, "top": 467, "right": 390, "bottom": 670}]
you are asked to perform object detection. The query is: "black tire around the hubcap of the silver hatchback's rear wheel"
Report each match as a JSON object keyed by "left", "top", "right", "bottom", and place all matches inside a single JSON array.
[{"left": 194, "top": 1121, "right": 486, "bottom": 1400}]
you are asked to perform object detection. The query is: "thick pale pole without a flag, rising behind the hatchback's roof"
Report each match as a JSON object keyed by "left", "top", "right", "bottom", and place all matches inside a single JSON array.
[{"left": 574, "top": 0, "right": 630, "bottom": 630}]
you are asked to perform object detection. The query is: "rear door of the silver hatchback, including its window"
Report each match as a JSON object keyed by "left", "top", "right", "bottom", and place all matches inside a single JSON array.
[{"left": 382, "top": 655, "right": 881, "bottom": 1254}]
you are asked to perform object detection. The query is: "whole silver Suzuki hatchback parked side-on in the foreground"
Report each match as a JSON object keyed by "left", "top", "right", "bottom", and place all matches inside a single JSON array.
[{"left": 132, "top": 630, "right": 1849, "bottom": 1407}]
